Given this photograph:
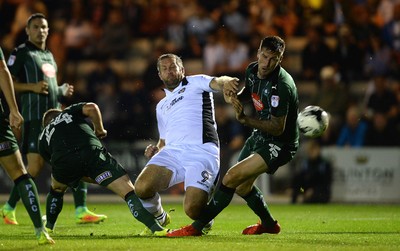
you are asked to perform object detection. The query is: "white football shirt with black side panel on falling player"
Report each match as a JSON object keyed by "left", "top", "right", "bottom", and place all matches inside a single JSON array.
[{"left": 156, "top": 74, "right": 219, "bottom": 146}]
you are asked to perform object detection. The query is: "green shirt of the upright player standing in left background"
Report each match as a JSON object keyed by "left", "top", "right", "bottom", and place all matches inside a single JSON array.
[{"left": 7, "top": 41, "right": 61, "bottom": 122}]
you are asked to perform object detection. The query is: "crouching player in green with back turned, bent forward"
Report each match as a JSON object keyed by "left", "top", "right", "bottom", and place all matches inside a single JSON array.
[{"left": 39, "top": 103, "right": 166, "bottom": 233}]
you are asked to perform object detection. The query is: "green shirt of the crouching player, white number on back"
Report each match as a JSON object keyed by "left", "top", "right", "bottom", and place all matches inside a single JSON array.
[{"left": 39, "top": 103, "right": 102, "bottom": 165}]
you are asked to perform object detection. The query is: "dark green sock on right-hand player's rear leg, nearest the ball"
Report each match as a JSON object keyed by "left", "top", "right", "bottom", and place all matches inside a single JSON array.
[{"left": 242, "top": 186, "right": 275, "bottom": 227}]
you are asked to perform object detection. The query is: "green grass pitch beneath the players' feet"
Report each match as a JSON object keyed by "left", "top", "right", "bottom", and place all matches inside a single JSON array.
[{"left": 0, "top": 201, "right": 400, "bottom": 251}]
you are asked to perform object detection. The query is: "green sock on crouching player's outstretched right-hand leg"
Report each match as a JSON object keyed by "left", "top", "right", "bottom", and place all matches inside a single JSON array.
[{"left": 125, "top": 191, "right": 163, "bottom": 232}]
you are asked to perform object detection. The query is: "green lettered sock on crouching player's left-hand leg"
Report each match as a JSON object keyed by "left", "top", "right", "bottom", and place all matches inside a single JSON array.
[{"left": 46, "top": 188, "right": 64, "bottom": 229}]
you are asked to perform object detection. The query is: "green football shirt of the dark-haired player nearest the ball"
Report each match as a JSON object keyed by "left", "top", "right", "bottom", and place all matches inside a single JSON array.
[{"left": 244, "top": 62, "right": 299, "bottom": 146}]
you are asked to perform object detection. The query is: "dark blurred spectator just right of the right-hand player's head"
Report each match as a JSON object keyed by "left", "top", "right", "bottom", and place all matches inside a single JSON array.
[{"left": 301, "top": 26, "right": 333, "bottom": 83}]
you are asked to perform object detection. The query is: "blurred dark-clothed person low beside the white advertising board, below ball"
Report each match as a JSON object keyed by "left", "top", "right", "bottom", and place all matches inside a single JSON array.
[{"left": 292, "top": 140, "right": 333, "bottom": 204}]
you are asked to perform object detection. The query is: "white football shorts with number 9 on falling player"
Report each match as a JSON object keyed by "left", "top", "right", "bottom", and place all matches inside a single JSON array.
[{"left": 147, "top": 143, "right": 219, "bottom": 193}]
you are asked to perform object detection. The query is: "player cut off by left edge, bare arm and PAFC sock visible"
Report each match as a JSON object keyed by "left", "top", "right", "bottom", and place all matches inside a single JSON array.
[{"left": 0, "top": 48, "right": 54, "bottom": 244}]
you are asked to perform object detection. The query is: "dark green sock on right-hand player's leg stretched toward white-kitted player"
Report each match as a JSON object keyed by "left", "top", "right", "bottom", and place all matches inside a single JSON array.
[{"left": 192, "top": 184, "right": 235, "bottom": 231}]
